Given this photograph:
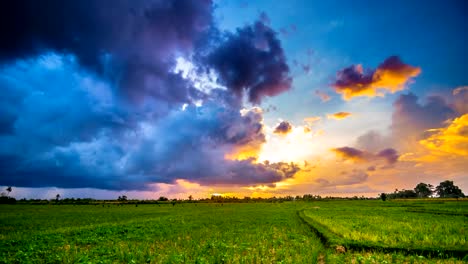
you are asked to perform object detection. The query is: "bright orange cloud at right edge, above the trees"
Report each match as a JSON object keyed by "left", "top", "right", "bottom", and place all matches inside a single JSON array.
[{"left": 419, "top": 114, "right": 468, "bottom": 156}]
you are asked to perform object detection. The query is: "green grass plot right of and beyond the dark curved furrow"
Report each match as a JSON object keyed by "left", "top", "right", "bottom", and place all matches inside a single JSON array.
[{"left": 303, "top": 201, "right": 468, "bottom": 257}]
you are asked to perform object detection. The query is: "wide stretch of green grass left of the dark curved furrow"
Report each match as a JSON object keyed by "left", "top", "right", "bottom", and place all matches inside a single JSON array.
[{"left": 0, "top": 203, "right": 323, "bottom": 263}]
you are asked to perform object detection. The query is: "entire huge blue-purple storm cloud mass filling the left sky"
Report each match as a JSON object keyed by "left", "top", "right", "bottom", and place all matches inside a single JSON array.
[{"left": 0, "top": 0, "right": 299, "bottom": 190}]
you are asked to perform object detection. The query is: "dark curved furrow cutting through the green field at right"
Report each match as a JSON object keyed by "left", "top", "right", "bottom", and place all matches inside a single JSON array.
[{"left": 296, "top": 209, "right": 468, "bottom": 260}]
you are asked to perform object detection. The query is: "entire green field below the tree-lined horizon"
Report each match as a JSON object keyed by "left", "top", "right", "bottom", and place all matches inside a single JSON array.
[{"left": 0, "top": 201, "right": 468, "bottom": 263}]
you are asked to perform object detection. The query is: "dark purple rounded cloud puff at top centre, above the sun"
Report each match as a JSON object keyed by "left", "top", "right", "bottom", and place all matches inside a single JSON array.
[{"left": 206, "top": 22, "right": 292, "bottom": 104}]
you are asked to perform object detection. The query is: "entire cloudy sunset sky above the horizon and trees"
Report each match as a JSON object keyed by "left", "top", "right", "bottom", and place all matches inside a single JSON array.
[{"left": 0, "top": 0, "right": 468, "bottom": 199}]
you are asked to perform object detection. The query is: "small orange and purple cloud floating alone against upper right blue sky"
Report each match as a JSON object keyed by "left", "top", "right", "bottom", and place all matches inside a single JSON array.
[{"left": 332, "top": 56, "right": 421, "bottom": 100}]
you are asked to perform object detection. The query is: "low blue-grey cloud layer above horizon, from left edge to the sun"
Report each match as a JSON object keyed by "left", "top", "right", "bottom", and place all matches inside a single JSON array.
[{"left": 0, "top": 83, "right": 299, "bottom": 189}]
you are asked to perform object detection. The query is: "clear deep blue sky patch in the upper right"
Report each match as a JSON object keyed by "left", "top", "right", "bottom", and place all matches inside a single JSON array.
[{"left": 215, "top": 1, "right": 468, "bottom": 117}]
